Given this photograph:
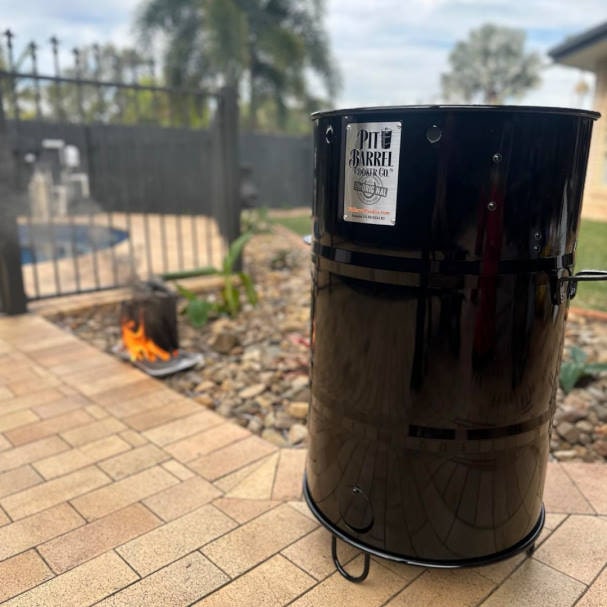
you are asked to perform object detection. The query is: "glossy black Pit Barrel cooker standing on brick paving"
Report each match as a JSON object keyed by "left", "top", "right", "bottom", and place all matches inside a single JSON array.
[{"left": 304, "top": 106, "right": 607, "bottom": 582}]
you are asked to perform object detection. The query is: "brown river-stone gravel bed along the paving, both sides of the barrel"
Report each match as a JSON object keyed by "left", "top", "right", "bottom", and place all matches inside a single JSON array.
[{"left": 49, "top": 228, "right": 607, "bottom": 461}]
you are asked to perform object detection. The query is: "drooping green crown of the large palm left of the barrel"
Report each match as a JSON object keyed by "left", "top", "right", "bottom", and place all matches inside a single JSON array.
[{"left": 137, "top": 0, "right": 339, "bottom": 129}]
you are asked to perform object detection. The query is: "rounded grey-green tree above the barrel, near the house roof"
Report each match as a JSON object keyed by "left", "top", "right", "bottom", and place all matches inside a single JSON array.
[{"left": 441, "top": 24, "right": 541, "bottom": 104}]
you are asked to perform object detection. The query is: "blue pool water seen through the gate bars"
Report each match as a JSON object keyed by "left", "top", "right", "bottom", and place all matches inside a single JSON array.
[{"left": 19, "top": 223, "right": 129, "bottom": 264}]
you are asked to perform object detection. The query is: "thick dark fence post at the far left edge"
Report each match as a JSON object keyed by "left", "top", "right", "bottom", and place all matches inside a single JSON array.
[{"left": 0, "top": 87, "right": 27, "bottom": 314}]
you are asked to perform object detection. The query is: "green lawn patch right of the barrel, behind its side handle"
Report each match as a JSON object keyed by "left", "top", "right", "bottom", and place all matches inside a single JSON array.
[{"left": 572, "top": 219, "right": 607, "bottom": 310}]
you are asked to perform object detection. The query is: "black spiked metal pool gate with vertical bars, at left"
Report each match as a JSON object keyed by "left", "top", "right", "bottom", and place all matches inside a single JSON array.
[{"left": 0, "top": 31, "right": 240, "bottom": 314}]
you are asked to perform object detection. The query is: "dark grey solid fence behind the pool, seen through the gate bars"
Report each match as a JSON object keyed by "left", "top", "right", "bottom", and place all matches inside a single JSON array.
[{"left": 7, "top": 120, "right": 213, "bottom": 216}]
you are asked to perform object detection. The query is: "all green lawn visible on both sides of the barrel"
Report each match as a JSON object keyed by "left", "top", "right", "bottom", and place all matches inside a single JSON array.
[{"left": 270, "top": 212, "right": 607, "bottom": 311}]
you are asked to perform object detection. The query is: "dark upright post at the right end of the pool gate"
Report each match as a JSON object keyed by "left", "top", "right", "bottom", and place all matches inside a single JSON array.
[{"left": 213, "top": 86, "right": 242, "bottom": 271}]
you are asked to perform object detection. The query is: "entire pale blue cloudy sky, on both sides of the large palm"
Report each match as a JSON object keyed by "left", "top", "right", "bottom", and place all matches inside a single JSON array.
[{"left": 0, "top": 0, "right": 607, "bottom": 108}]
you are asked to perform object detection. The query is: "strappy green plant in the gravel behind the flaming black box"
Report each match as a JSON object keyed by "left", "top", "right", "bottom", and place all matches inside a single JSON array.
[{"left": 176, "top": 232, "right": 258, "bottom": 327}]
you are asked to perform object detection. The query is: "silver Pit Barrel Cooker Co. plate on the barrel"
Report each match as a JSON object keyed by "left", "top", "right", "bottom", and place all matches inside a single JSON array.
[{"left": 344, "top": 122, "right": 402, "bottom": 226}]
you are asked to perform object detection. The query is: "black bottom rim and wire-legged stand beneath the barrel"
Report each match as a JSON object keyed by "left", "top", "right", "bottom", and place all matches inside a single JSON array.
[{"left": 303, "top": 475, "right": 546, "bottom": 583}]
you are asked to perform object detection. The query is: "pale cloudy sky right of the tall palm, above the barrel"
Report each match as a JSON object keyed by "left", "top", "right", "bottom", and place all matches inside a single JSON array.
[{"left": 326, "top": 0, "right": 605, "bottom": 107}]
